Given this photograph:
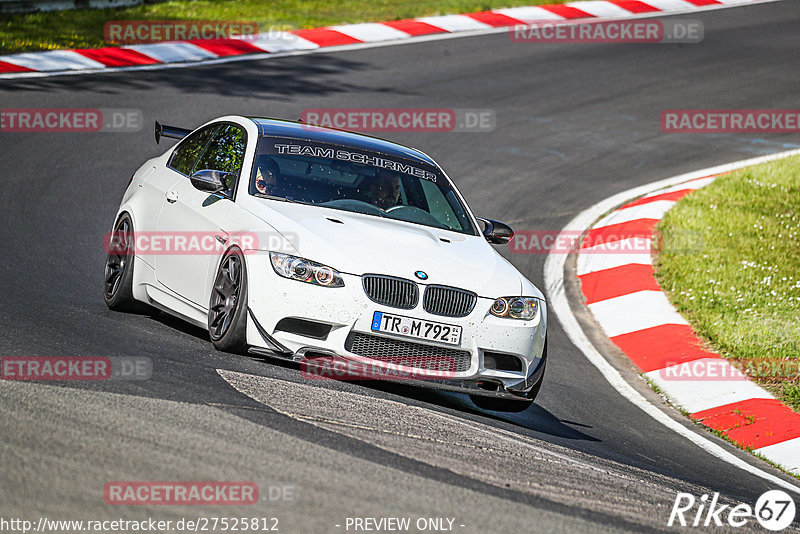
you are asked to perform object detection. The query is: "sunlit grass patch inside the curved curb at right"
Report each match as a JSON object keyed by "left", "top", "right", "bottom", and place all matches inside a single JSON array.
[{"left": 654, "top": 157, "right": 800, "bottom": 411}]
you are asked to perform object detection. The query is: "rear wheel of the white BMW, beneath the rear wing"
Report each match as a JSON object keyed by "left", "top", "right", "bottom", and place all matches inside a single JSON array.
[{"left": 103, "top": 213, "right": 146, "bottom": 311}]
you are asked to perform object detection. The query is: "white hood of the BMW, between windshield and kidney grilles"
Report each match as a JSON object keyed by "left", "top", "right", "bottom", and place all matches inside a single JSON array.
[{"left": 248, "top": 199, "right": 541, "bottom": 298}]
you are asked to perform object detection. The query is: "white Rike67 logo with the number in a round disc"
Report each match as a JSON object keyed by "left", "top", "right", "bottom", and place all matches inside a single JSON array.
[{"left": 667, "top": 490, "right": 795, "bottom": 531}]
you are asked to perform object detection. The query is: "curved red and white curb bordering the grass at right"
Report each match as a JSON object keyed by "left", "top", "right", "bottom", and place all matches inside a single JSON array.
[{"left": 577, "top": 169, "right": 800, "bottom": 474}]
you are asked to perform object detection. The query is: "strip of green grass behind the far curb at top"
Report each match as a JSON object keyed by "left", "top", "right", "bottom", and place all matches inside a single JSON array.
[{"left": 0, "top": 0, "right": 566, "bottom": 54}]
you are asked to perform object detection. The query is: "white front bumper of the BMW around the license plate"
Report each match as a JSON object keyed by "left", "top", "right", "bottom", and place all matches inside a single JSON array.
[{"left": 247, "top": 252, "right": 547, "bottom": 399}]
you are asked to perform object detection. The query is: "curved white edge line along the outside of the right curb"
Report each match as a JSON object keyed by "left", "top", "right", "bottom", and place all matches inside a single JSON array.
[{"left": 544, "top": 150, "right": 800, "bottom": 494}]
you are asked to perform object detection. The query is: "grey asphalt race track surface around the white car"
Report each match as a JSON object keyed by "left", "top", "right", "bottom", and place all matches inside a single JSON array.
[{"left": 0, "top": 2, "right": 800, "bottom": 533}]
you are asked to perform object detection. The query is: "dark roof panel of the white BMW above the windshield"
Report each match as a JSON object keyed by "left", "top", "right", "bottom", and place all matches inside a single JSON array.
[{"left": 250, "top": 117, "right": 438, "bottom": 168}]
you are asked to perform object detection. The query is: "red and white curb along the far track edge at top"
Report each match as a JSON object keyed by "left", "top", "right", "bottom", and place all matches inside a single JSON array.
[{"left": 0, "top": 0, "right": 771, "bottom": 79}]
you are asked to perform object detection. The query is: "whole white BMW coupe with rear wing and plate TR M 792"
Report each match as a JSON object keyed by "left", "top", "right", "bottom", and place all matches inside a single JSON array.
[{"left": 103, "top": 116, "right": 547, "bottom": 411}]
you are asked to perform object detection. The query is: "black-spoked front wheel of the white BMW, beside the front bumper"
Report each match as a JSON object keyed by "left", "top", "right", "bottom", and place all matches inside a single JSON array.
[{"left": 208, "top": 248, "right": 247, "bottom": 354}]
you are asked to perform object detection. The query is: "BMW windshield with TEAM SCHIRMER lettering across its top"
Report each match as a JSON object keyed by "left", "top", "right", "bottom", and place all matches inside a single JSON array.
[{"left": 250, "top": 137, "right": 476, "bottom": 235}]
